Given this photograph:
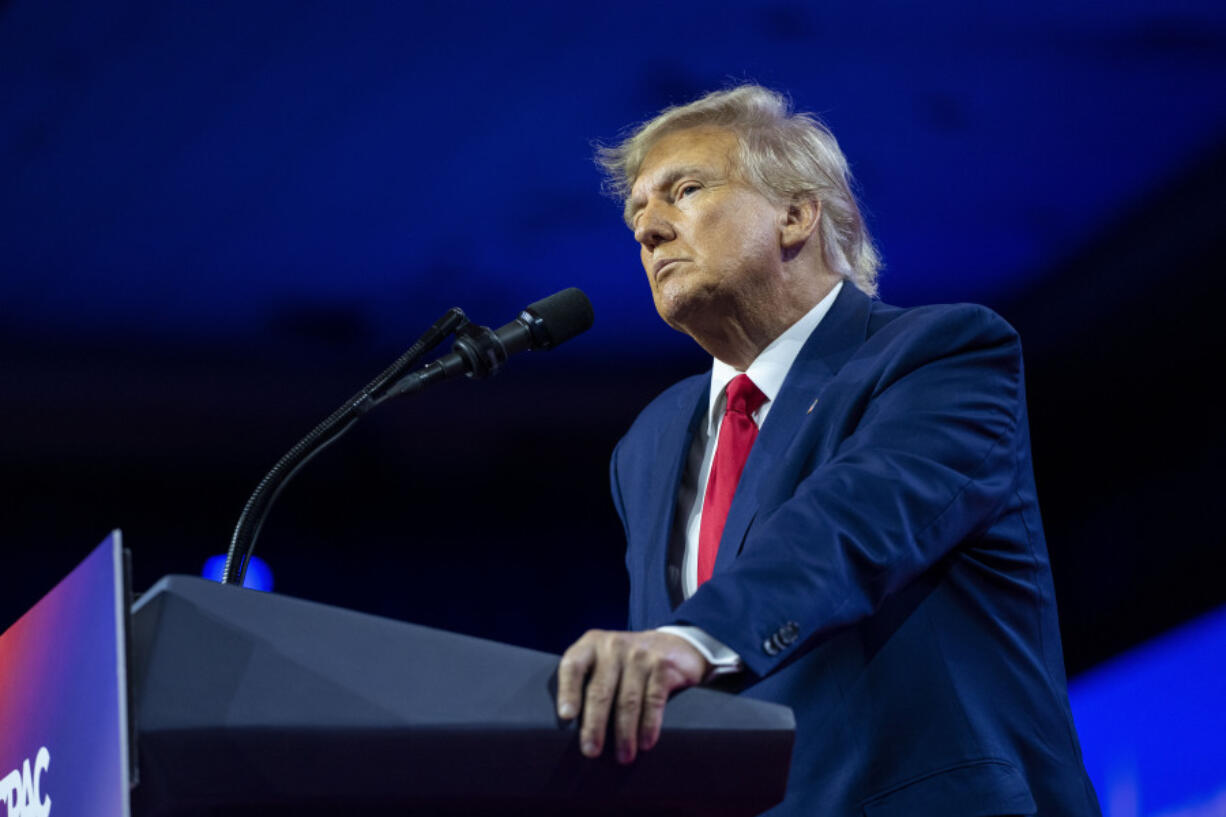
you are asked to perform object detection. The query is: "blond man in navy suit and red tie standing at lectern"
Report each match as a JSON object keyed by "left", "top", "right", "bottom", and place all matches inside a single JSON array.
[{"left": 558, "top": 86, "right": 1098, "bottom": 817}]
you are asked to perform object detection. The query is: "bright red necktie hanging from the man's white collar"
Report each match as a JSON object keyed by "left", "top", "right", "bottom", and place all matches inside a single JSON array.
[{"left": 698, "top": 374, "right": 766, "bottom": 585}]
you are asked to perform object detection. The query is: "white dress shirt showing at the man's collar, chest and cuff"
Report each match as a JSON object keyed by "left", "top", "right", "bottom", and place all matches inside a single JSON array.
[{"left": 660, "top": 281, "right": 843, "bottom": 675}]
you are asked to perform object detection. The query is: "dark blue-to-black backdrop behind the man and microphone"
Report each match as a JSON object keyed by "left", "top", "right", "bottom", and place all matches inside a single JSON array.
[{"left": 0, "top": 0, "right": 1226, "bottom": 672}]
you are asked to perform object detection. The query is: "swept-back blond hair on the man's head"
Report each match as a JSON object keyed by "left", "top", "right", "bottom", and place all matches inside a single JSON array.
[{"left": 596, "top": 85, "right": 881, "bottom": 296}]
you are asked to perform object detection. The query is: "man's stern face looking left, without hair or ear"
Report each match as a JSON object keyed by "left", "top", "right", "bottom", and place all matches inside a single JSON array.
[{"left": 628, "top": 128, "right": 785, "bottom": 335}]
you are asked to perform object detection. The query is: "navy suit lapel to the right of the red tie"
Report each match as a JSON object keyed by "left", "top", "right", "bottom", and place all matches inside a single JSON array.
[{"left": 715, "top": 282, "right": 872, "bottom": 573}]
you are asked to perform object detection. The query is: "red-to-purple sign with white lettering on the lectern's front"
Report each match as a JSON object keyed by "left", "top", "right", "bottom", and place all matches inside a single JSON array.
[{"left": 0, "top": 531, "right": 130, "bottom": 817}]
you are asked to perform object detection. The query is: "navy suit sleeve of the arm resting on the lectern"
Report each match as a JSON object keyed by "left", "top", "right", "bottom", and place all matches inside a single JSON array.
[{"left": 676, "top": 307, "right": 1024, "bottom": 676}]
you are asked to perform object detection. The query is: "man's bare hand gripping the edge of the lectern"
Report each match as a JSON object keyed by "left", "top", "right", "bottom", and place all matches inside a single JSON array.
[{"left": 558, "top": 629, "right": 711, "bottom": 763}]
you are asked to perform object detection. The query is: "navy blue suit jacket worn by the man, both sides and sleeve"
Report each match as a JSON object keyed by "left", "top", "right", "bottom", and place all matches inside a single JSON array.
[{"left": 612, "top": 285, "right": 1098, "bottom": 817}]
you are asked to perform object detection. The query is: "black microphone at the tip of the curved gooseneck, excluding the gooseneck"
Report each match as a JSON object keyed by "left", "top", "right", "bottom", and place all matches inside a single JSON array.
[{"left": 380, "top": 287, "right": 593, "bottom": 402}]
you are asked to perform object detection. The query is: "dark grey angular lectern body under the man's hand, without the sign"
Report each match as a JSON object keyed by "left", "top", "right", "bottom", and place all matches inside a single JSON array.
[{"left": 132, "top": 577, "right": 793, "bottom": 817}]
